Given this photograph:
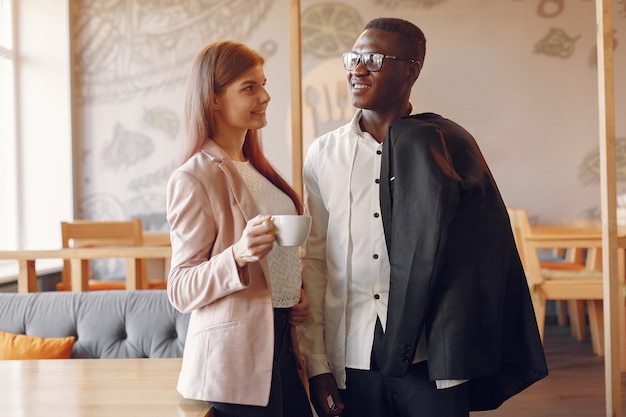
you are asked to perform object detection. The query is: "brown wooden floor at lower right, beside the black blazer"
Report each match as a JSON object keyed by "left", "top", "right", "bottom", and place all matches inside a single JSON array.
[{"left": 470, "top": 325, "right": 626, "bottom": 417}]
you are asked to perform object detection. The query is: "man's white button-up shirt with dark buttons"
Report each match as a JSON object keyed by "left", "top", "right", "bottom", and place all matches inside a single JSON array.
[{"left": 300, "top": 110, "right": 426, "bottom": 388}]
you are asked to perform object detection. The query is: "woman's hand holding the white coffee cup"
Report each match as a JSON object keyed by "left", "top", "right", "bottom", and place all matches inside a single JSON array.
[{"left": 233, "top": 214, "right": 276, "bottom": 267}]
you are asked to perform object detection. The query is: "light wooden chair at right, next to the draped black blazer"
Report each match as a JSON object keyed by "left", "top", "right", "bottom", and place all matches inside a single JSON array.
[{"left": 508, "top": 208, "right": 604, "bottom": 355}]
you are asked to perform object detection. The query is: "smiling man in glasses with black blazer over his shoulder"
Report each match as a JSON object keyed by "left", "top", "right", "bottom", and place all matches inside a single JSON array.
[{"left": 300, "top": 18, "right": 547, "bottom": 417}]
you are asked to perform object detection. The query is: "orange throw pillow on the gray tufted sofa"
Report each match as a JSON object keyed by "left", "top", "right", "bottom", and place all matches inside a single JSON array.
[{"left": 0, "top": 331, "right": 76, "bottom": 359}]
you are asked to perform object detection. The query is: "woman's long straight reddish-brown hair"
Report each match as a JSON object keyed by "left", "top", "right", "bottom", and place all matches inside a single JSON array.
[{"left": 183, "top": 40, "right": 304, "bottom": 214}]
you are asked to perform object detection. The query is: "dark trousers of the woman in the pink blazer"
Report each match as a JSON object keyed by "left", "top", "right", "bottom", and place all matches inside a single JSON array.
[{"left": 209, "top": 308, "right": 313, "bottom": 417}]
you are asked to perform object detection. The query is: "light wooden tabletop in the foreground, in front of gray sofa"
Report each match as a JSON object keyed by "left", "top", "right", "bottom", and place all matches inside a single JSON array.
[{"left": 0, "top": 359, "right": 213, "bottom": 417}]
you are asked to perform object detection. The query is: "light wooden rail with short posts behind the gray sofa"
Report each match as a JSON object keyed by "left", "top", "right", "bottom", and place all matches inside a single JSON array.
[{"left": 0, "top": 246, "right": 172, "bottom": 292}]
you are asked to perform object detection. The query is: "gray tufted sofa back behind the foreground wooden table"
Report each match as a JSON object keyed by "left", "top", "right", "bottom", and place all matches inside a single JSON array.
[{"left": 0, "top": 290, "right": 189, "bottom": 358}]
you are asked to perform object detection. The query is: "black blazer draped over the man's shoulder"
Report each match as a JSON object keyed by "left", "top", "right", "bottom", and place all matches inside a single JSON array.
[{"left": 377, "top": 113, "right": 548, "bottom": 410}]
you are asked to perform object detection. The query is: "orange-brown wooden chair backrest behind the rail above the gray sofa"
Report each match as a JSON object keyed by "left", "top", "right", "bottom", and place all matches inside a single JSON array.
[{"left": 61, "top": 219, "right": 146, "bottom": 290}]
